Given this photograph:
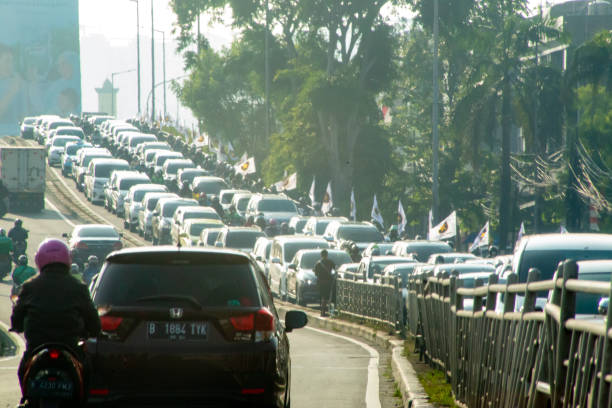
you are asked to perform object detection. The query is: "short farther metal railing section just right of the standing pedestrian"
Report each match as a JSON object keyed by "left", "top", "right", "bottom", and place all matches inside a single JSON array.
[{"left": 336, "top": 273, "right": 403, "bottom": 330}]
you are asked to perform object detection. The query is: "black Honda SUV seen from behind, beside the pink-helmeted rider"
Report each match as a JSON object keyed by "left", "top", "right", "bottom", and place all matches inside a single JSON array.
[{"left": 88, "top": 247, "right": 307, "bottom": 407}]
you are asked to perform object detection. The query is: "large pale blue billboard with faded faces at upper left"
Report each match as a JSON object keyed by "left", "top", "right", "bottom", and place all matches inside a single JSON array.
[{"left": 0, "top": 0, "right": 81, "bottom": 136}]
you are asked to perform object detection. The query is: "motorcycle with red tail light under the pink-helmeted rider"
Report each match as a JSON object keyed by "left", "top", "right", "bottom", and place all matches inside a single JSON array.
[{"left": 22, "top": 343, "right": 86, "bottom": 408}]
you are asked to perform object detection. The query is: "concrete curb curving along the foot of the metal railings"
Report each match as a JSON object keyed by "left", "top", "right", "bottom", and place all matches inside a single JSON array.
[{"left": 275, "top": 299, "right": 434, "bottom": 408}]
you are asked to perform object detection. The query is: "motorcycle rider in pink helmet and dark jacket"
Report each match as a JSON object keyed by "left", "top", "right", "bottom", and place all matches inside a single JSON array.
[{"left": 11, "top": 238, "right": 101, "bottom": 404}]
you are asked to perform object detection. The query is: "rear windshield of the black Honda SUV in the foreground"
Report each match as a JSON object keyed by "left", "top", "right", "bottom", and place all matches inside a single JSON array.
[{"left": 94, "top": 254, "right": 261, "bottom": 307}]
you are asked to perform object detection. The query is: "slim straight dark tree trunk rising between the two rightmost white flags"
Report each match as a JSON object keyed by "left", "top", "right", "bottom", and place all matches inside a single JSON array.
[{"left": 499, "top": 77, "right": 512, "bottom": 251}]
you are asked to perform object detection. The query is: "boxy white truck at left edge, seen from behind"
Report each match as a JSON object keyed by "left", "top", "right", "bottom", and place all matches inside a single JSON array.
[{"left": 0, "top": 146, "right": 46, "bottom": 212}]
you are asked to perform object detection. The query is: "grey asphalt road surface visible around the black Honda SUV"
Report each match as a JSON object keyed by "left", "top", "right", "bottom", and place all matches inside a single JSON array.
[{"left": 0, "top": 165, "right": 388, "bottom": 408}]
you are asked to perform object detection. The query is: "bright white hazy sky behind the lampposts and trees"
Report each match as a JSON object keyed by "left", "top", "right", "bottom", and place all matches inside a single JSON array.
[{"left": 79, "top": 0, "right": 563, "bottom": 125}]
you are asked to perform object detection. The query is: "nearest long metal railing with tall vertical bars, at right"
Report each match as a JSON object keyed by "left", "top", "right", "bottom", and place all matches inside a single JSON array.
[{"left": 406, "top": 261, "right": 612, "bottom": 408}]
